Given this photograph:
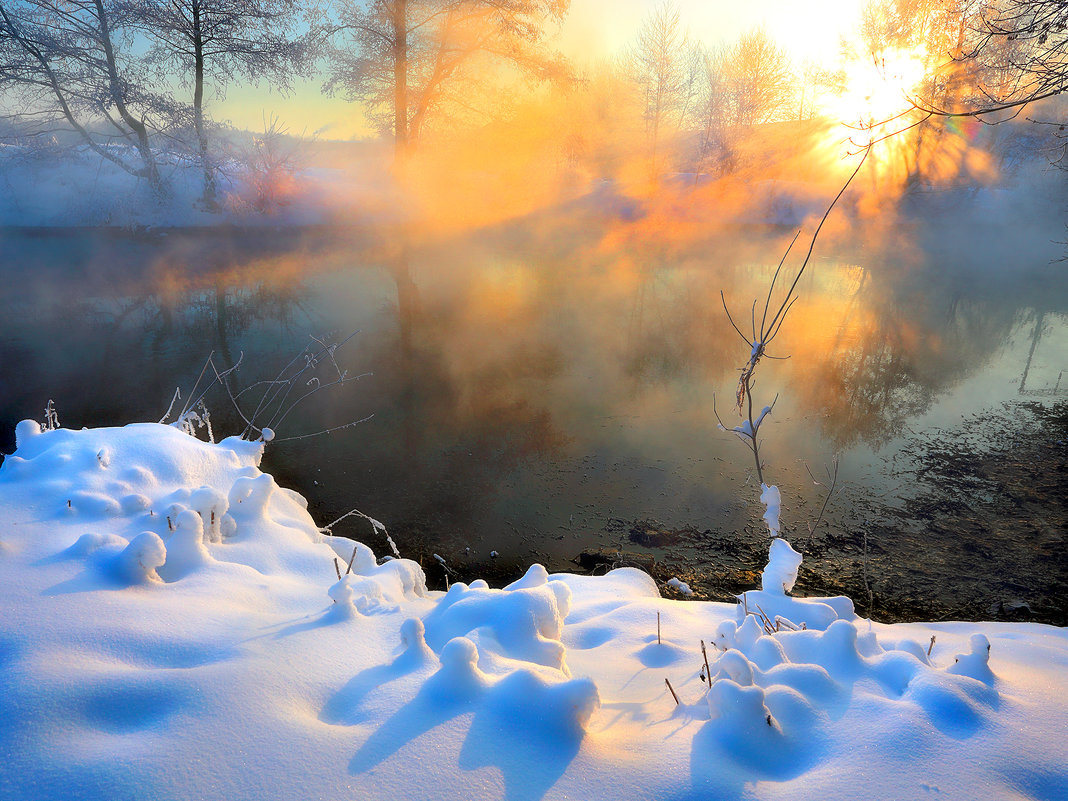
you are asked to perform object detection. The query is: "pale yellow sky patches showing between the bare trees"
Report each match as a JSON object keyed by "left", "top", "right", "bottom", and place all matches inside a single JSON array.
[{"left": 221, "top": 0, "right": 863, "bottom": 139}]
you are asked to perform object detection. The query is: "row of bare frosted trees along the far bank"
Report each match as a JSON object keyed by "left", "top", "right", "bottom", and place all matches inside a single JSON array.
[{"left": 0, "top": 0, "right": 1068, "bottom": 206}]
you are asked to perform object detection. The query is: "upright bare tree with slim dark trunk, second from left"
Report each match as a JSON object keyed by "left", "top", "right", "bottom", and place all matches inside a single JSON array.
[{"left": 119, "top": 0, "right": 310, "bottom": 207}]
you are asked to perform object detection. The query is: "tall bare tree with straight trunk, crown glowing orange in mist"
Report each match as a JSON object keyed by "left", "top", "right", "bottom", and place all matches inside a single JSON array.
[{"left": 325, "top": 0, "right": 570, "bottom": 164}]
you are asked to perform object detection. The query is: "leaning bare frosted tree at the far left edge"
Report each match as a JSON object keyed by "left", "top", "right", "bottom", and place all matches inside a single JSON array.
[{"left": 0, "top": 0, "right": 167, "bottom": 193}]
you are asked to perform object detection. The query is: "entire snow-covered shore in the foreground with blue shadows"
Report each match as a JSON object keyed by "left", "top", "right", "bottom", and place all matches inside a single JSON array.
[{"left": 0, "top": 422, "right": 1068, "bottom": 801}]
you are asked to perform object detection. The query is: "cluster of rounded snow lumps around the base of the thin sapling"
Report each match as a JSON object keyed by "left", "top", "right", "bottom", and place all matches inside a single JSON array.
[{"left": 692, "top": 539, "right": 1000, "bottom": 772}]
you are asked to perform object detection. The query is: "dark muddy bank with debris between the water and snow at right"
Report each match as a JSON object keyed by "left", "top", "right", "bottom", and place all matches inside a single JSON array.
[{"left": 417, "top": 401, "right": 1068, "bottom": 626}]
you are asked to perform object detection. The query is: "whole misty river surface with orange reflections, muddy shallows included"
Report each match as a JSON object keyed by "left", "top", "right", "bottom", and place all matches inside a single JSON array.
[{"left": 0, "top": 205, "right": 1068, "bottom": 625}]
